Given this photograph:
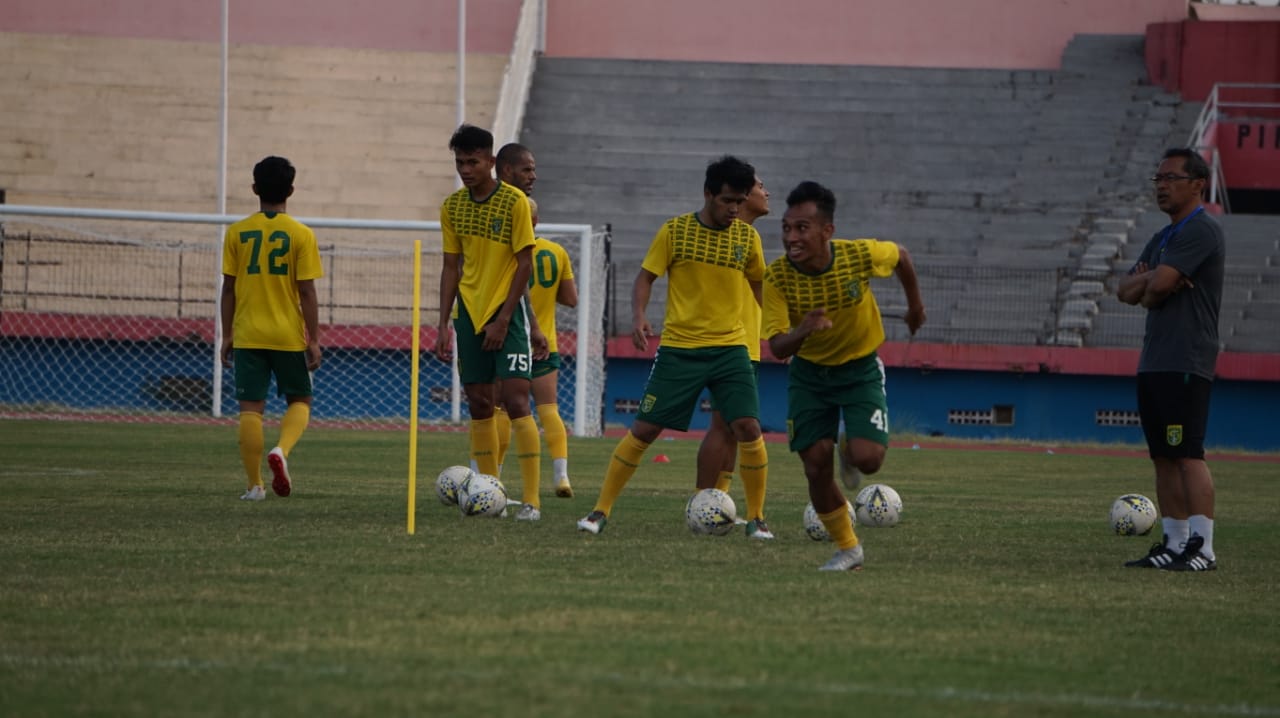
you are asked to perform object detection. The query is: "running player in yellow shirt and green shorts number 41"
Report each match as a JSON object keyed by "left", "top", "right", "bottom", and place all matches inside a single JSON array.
[{"left": 763, "top": 182, "right": 924, "bottom": 571}]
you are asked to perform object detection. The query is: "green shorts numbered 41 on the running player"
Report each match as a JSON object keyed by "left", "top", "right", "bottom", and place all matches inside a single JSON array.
[{"left": 787, "top": 353, "right": 888, "bottom": 452}]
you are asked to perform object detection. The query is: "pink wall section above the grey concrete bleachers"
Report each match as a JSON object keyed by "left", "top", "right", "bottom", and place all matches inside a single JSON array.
[{"left": 547, "top": 0, "right": 1187, "bottom": 69}]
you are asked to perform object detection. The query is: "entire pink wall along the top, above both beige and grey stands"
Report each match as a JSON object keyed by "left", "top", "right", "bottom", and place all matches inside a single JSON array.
[{"left": 0, "top": 0, "right": 1187, "bottom": 69}]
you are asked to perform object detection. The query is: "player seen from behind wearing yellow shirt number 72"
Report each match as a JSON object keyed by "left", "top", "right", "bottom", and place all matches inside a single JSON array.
[{"left": 220, "top": 156, "right": 324, "bottom": 502}]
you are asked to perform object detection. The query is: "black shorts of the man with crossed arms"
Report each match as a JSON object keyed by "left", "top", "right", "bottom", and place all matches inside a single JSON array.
[{"left": 1138, "top": 371, "right": 1213, "bottom": 458}]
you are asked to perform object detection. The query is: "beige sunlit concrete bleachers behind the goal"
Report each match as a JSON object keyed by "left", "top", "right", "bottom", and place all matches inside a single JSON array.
[{"left": 0, "top": 33, "right": 507, "bottom": 227}]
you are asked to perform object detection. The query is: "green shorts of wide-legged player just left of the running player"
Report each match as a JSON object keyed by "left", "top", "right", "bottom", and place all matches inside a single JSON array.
[{"left": 636, "top": 344, "right": 760, "bottom": 431}]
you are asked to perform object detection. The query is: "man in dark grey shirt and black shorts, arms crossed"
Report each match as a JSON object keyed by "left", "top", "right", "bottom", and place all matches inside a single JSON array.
[{"left": 1116, "top": 148, "right": 1226, "bottom": 571}]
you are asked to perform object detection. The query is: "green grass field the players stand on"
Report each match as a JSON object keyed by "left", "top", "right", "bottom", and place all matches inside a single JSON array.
[{"left": 0, "top": 421, "right": 1280, "bottom": 718}]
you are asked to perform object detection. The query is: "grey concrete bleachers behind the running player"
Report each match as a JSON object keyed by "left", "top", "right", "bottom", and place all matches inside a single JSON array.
[{"left": 521, "top": 36, "right": 1172, "bottom": 344}]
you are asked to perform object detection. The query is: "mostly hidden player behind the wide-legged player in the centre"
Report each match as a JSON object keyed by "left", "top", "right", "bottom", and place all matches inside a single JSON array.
[{"left": 698, "top": 177, "right": 773, "bottom": 539}]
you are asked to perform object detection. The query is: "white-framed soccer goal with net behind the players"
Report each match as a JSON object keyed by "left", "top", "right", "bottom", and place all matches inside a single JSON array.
[{"left": 0, "top": 205, "right": 608, "bottom": 436}]
